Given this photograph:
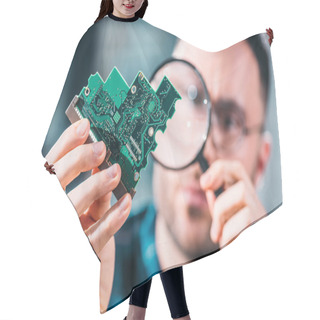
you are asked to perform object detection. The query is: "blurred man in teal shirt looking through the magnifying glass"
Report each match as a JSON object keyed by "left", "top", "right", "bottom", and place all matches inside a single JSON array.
[{"left": 109, "top": 31, "right": 271, "bottom": 307}]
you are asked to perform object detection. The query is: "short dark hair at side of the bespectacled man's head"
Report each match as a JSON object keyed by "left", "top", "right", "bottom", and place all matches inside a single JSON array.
[{"left": 246, "top": 33, "right": 270, "bottom": 110}]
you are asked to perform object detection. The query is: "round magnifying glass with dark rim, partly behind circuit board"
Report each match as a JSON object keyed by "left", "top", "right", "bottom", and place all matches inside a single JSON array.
[{"left": 150, "top": 58, "right": 223, "bottom": 196}]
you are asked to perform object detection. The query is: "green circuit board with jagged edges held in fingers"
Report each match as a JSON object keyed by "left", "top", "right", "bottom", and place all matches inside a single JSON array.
[{"left": 66, "top": 67, "right": 181, "bottom": 199}]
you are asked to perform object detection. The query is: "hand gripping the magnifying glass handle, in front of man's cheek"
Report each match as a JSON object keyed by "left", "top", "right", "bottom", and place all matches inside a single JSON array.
[{"left": 200, "top": 159, "right": 266, "bottom": 247}]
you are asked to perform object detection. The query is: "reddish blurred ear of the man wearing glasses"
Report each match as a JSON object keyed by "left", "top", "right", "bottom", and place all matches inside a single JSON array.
[{"left": 254, "top": 131, "right": 272, "bottom": 187}]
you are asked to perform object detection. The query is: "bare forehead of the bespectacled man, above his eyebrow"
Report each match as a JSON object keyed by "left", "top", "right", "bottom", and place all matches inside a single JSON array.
[{"left": 173, "top": 41, "right": 263, "bottom": 120}]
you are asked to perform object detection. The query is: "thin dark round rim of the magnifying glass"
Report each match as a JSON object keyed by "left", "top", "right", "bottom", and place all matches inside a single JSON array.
[{"left": 149, "top": 57, "right": 211, "bottom": 170}]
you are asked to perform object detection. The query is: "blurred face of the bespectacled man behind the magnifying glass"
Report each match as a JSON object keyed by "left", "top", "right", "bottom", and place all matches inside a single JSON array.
[{"left": 154, "top": 41, "right": 264, "bottom": 258}]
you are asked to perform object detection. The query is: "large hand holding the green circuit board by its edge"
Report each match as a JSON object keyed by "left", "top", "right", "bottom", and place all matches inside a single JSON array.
[{"left": 45, "top": 119, "right": 131, "bottom": 260}]
